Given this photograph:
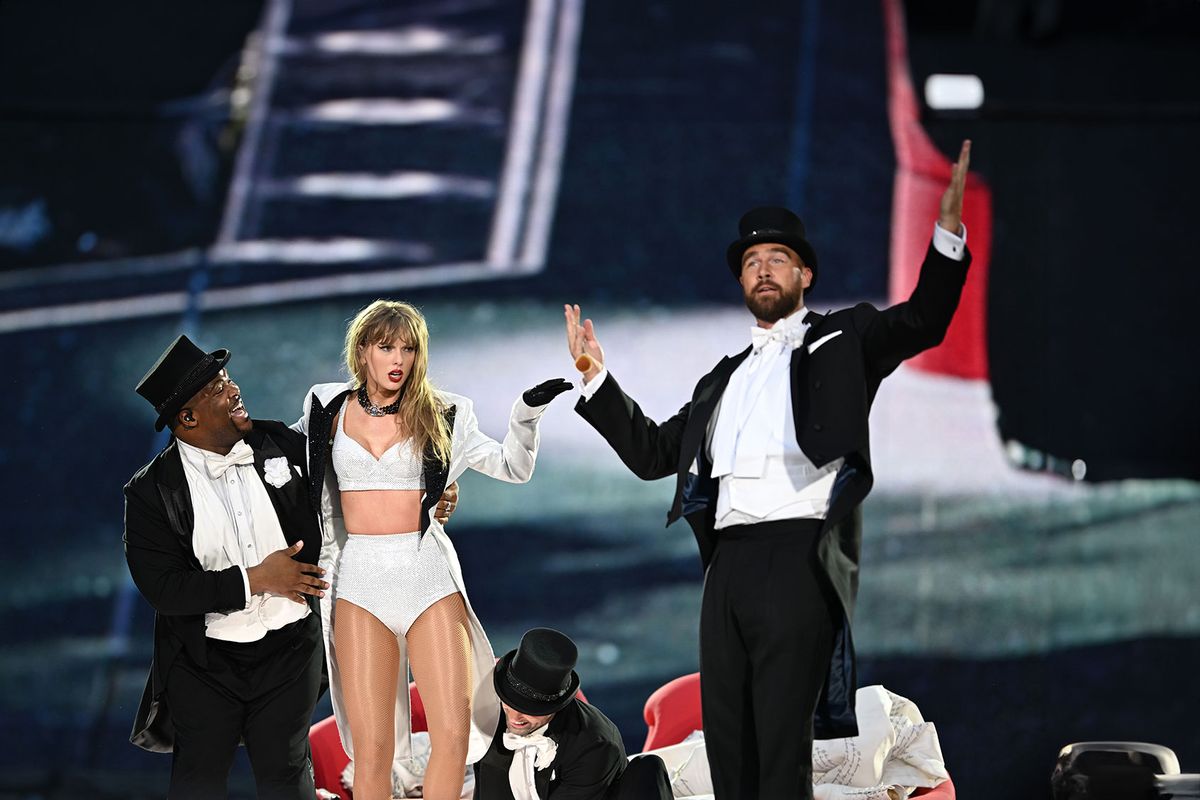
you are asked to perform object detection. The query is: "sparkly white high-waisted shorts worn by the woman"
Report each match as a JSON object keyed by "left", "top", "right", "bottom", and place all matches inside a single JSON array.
[{"left": 334, "top": 533, "right": 458, "bottom": 636}]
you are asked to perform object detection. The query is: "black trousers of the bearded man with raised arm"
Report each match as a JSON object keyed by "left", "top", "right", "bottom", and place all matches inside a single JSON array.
[{"left": 700, "top": 519, "right": 842, "bottom": 800}]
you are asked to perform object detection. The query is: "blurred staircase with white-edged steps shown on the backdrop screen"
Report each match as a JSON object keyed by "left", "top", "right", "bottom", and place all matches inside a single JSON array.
[{"left": 0, "top": 0, "right": 583, "bottom": 331}]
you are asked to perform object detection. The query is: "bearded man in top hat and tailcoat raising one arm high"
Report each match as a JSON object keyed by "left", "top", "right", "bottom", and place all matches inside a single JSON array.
[{"left": 564, "top": 142, "right": 971, "bottom": 800}]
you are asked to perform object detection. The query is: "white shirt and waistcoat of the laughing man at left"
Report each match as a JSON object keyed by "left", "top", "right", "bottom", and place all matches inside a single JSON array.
[{"left": 176, "top": 440, "right": 308, "bottom": 642}]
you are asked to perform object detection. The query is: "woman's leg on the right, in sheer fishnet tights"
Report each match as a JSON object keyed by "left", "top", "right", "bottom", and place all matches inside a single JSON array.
[{"left": 408, "top": 594, "right": 475, "bottom": 800}]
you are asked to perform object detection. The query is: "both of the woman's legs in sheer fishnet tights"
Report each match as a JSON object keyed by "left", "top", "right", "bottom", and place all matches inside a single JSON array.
[{"left": 334, "top": 594, "right": 474, "bottom": 800}]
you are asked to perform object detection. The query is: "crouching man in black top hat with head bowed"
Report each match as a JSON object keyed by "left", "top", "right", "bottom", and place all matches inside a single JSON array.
[{"left": 475, "top": 627, "right": 671, "bottom": 800}]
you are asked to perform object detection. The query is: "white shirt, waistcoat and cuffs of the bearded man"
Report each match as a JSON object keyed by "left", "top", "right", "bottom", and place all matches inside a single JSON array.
[{"left": 580, "top": 224, "right": 966, "bottom": 529}]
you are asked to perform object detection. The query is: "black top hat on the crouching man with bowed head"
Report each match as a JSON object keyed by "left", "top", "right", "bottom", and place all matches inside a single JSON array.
[{"left": 492, "top": 627, "right": 580, "bottom": 716}]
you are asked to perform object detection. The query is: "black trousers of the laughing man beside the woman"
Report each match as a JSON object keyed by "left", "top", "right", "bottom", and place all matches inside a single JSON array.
[{"left": 167, "top": 614, "right": 324, "bottom": 800}]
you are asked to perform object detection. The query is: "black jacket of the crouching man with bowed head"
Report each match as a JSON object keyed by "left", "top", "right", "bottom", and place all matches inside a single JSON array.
[{"left": 475, "top": 698, "right": 626, "bottom": 800}]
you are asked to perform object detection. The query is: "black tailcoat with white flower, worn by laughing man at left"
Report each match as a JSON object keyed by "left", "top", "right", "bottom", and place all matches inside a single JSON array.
[{"left": 125, "top": 420, "right": 320, "bottom": 752}]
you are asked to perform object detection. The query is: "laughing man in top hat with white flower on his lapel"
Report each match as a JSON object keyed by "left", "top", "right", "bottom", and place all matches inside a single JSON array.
[{"left": 125, "top": 336, "right": 329, "bottom": 800}]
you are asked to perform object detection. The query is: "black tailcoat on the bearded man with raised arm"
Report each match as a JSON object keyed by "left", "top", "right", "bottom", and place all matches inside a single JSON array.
[{"left": 576, "top": 239, "right": 971, "bottom": 739}]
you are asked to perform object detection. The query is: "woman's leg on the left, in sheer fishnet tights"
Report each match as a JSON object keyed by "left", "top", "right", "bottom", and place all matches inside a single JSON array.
[{"left": 334, "top": 600, "right": 400, "bottom": 800}]
